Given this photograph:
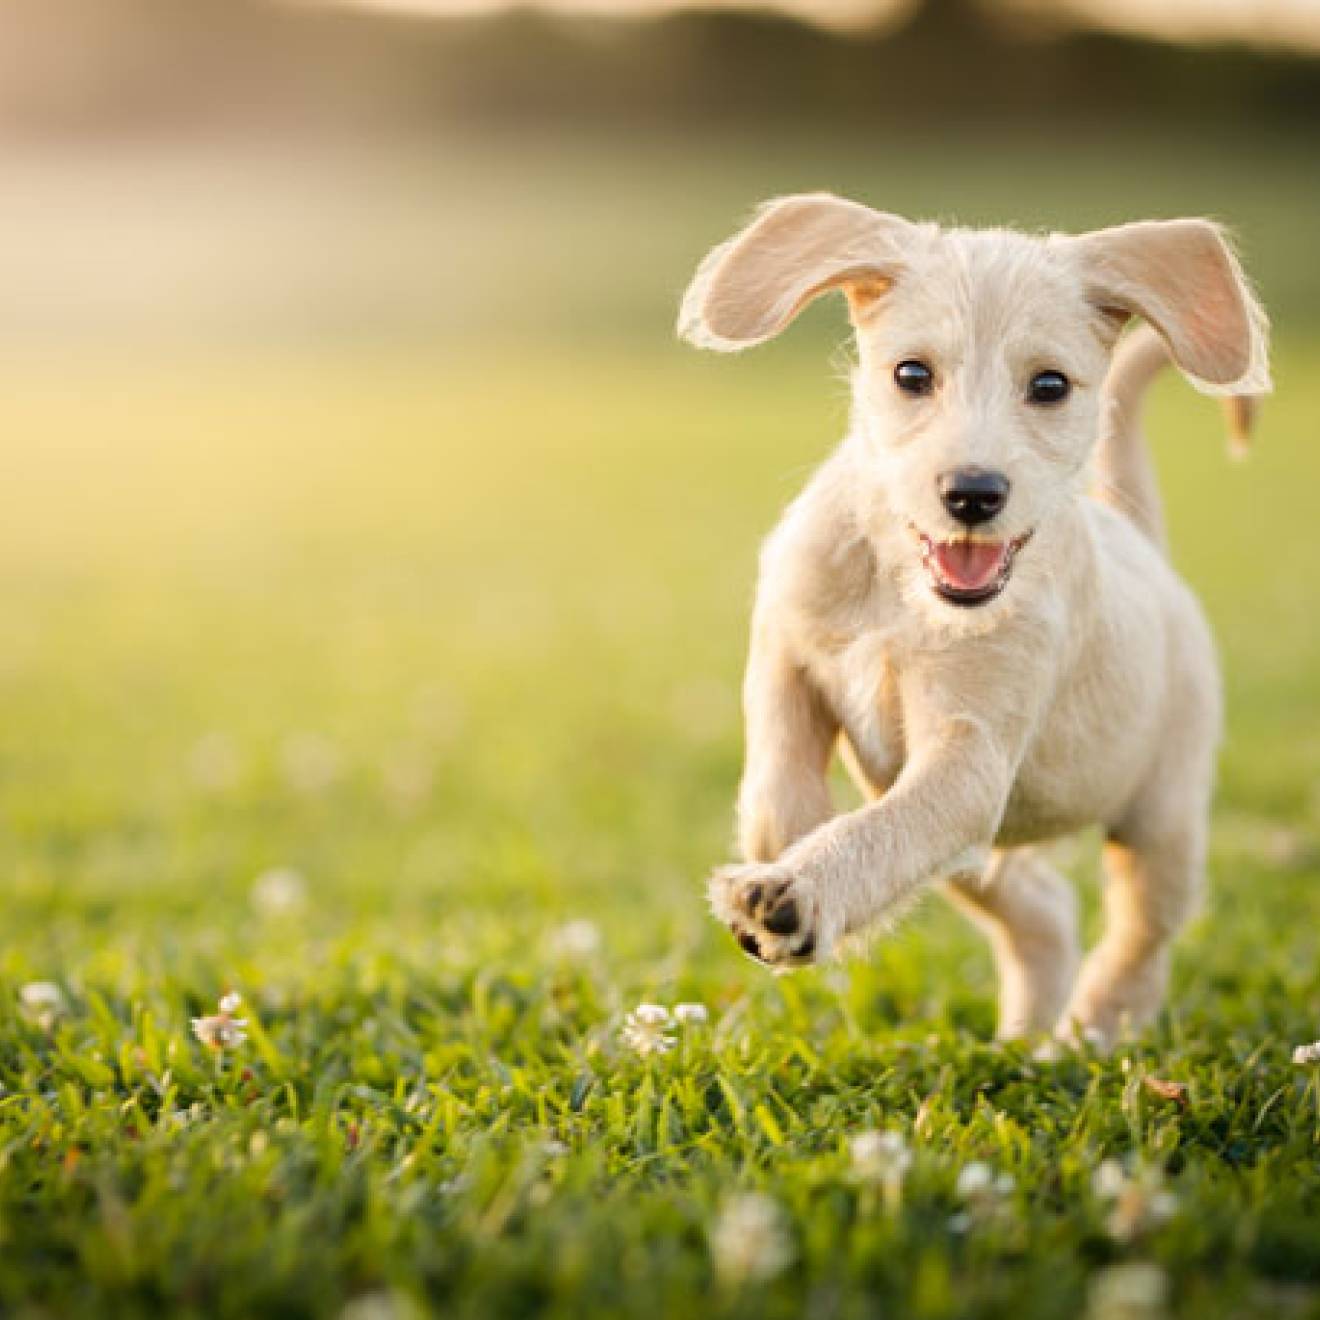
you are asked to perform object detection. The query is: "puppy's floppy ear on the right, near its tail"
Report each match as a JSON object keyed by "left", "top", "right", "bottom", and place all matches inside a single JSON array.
[{"left": 1071, "top": 220, "right": 1270, "bottom": 395}]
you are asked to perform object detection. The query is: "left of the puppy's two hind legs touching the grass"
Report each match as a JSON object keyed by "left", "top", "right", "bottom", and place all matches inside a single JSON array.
[{"left": 945, "top": 849, "right": 1080, "bottom": 1040}]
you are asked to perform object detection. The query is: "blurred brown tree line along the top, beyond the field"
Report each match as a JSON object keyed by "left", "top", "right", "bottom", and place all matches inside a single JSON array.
[{"left": 0, "top": 0, "right": 1320, "bottom": 136}]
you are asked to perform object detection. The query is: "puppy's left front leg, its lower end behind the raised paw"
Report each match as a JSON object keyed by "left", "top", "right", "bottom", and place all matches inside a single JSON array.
[{"left": 738, "top": 626, "right": 840, "bottom": 862}]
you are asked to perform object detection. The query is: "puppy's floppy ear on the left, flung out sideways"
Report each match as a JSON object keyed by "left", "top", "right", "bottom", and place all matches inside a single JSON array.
[{"left": 678, "top": 193, "right": 915, "bottom": 352}]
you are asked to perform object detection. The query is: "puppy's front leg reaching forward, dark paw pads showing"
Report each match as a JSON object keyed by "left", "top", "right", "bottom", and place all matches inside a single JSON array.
[{"left": 710, "top": 654, "right": 1039, "bottom": 968}]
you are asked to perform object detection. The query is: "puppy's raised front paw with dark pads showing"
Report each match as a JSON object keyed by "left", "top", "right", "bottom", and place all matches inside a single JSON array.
[{"left": 710, "top": 862, "right": 829, "bottom": 970}]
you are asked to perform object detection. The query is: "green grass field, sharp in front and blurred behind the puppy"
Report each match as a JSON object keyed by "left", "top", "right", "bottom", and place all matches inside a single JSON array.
[{"left": 0, "top": 128, "right": 1320, "bottom": 1320}]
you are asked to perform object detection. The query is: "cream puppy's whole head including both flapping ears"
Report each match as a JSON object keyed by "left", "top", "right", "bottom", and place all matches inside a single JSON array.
[{"left": 678, "top": 194, "right": 1269, "bottom": 607}]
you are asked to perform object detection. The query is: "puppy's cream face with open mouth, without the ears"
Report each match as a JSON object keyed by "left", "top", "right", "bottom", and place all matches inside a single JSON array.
[{"left": 853, "top": 231, "right": 1115, "bottom": 609}]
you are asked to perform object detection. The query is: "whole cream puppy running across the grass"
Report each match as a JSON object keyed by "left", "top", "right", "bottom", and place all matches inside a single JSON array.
[{"left": 678, "top": 194, "right": 1270, "bottom": 1044}]
